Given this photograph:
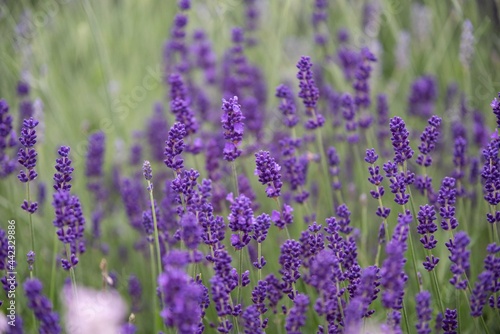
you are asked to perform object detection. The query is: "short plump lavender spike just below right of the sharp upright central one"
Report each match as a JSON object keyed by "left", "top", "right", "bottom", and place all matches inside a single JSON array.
[{"left": 255, "top": 151, "right": 283, "bottom": 198}]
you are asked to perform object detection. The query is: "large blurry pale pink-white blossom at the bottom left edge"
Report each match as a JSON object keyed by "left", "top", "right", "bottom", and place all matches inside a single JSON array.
[{"left": 63, "top": 286, "right": 127, "bottom": 334}]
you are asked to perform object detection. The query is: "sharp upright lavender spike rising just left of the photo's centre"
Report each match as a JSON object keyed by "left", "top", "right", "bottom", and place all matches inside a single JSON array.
[{"left": 221, "top": 96, "right": 245, "bottom": 161}]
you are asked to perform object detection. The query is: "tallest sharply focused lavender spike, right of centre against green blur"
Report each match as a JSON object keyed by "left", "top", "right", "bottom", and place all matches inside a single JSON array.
[{"left": 297, "top": 56, "right": 325, "bottom": 130}]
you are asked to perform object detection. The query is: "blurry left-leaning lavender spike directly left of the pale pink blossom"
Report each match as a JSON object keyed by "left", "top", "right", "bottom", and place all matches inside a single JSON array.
[{"left": 24, "top": 278, "right": 61, "bottom": 334}]
